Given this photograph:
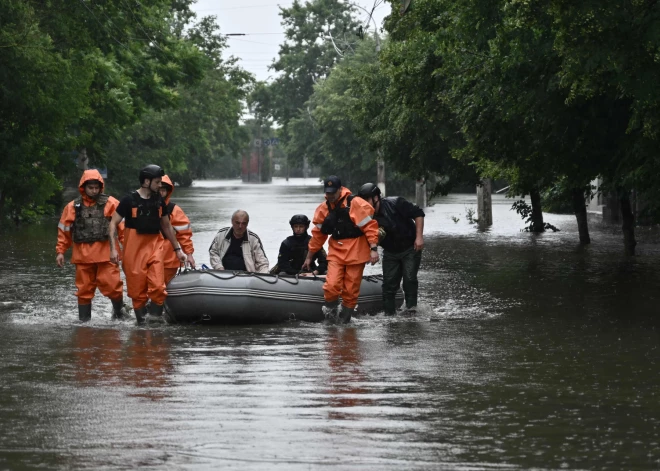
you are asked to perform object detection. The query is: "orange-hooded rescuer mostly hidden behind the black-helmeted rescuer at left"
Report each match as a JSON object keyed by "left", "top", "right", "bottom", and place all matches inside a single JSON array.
[{"left": 160, "top": 175, "right": 195, "bottom": 286}]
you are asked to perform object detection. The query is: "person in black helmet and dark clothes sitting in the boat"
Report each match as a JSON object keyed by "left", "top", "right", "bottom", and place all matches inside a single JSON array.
[{"left": 277, "top": 214, "right": 328, "bottom": 276}]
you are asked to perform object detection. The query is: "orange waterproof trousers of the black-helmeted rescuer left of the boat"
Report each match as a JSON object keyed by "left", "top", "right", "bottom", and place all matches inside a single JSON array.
[{"left": 122, "top": 228, "right": 167, "bottom": 309}]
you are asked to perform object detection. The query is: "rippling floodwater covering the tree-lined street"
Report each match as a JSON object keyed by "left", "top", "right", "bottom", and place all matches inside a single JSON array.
[{"left": 0, "top": 179, "right": 660, "bottom": 470}]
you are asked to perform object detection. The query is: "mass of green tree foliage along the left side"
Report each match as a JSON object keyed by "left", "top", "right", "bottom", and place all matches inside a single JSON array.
[{"left": 0, "top": 0, "right": 251, "bottom": 221}]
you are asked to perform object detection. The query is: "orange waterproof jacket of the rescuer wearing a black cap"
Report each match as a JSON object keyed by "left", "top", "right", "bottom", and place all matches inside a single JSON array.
[{"left": 309, "top": 187, "right": 378, "bottom": 265}]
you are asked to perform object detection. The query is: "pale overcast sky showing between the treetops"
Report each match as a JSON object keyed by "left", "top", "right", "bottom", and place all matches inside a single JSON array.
[{"left": 192, "top": 0, "right": 390, "bottom": 80}]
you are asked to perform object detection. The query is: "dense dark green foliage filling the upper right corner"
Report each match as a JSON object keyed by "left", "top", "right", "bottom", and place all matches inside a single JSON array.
[{"left": 376, "top": 0, "right": 660, "bottom": 226}]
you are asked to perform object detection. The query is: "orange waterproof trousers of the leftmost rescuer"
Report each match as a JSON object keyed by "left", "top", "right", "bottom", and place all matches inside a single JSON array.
[{"left": 76, "top": 262, "right": 124, "bottom": 304}]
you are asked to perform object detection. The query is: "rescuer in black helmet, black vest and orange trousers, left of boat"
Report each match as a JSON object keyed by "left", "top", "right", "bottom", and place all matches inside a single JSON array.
[{"left": 110, "top": 165, "right": 186, "bottom": 324}]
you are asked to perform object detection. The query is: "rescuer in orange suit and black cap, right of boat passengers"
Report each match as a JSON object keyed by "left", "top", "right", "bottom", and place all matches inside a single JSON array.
[{"left": 302, "top": 175, "right": 379, "bottom": 322}]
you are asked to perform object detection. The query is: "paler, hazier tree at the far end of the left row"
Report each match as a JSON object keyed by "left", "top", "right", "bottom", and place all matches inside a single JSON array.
[{"left": 108, "top": 17, "right": 253, "bottom": 190}]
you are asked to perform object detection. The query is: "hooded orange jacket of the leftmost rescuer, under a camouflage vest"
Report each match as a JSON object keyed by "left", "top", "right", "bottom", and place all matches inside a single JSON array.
[{"left": 55, "top": 170, "right": 124, "bottom": 263}]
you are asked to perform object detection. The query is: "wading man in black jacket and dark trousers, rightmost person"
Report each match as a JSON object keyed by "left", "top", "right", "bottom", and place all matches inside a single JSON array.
[{"left": 358, "top": 183, "right": 424, "bottom": 315}]
